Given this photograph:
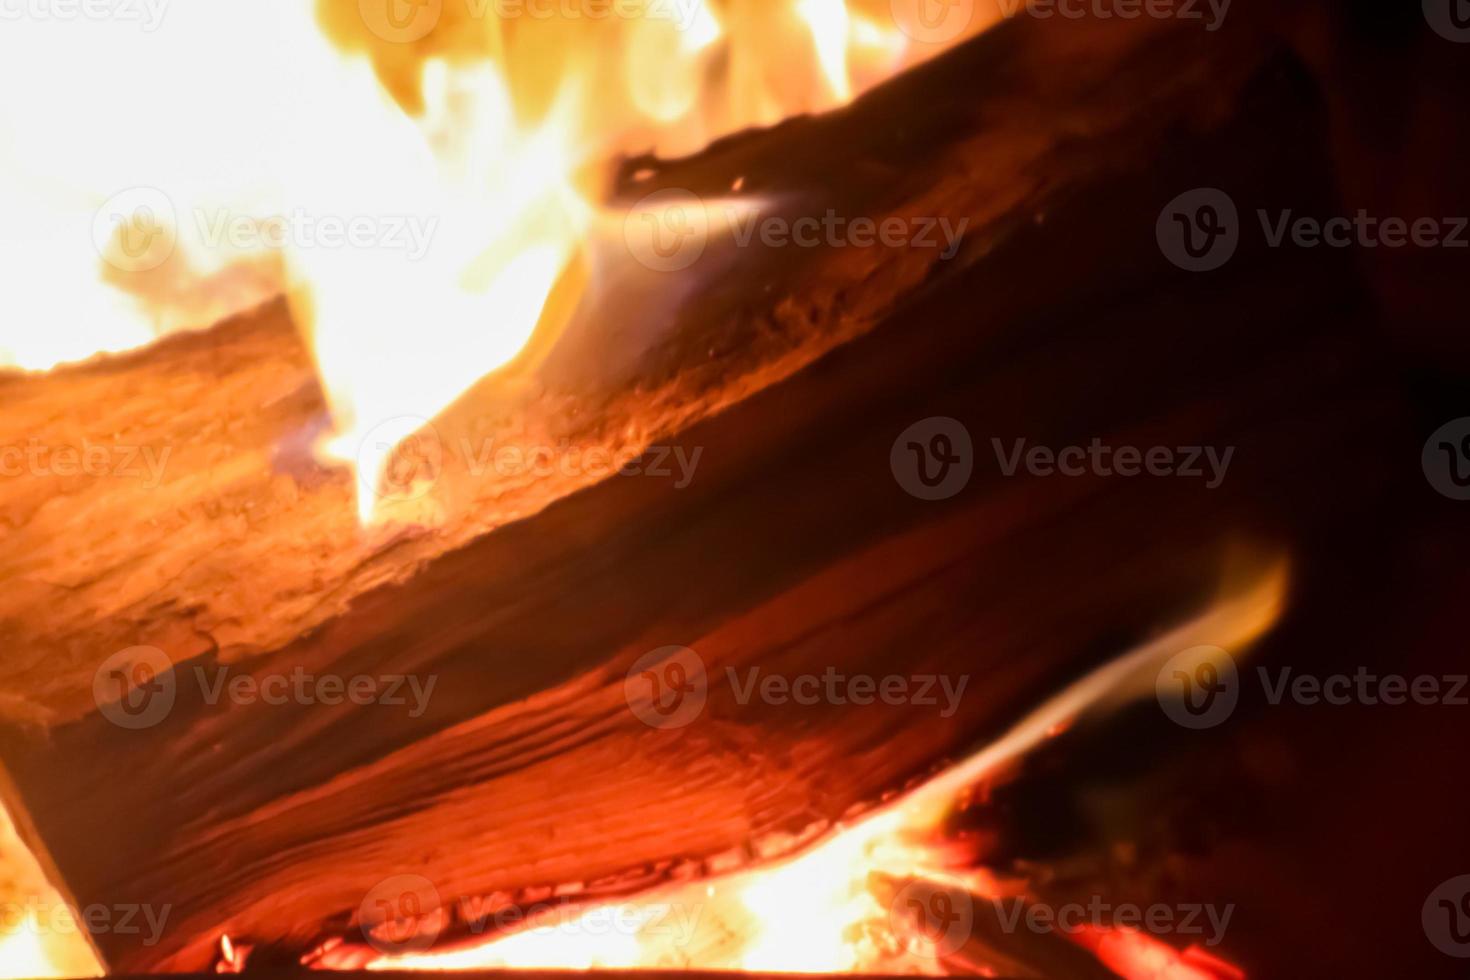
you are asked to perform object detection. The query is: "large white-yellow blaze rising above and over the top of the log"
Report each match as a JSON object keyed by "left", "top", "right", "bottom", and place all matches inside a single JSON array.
[{"left": 0, "top": 0, "right": 982, "bottom": 520}]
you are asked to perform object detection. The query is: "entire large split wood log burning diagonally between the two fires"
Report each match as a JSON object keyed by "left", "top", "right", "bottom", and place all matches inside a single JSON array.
[{"left": 0, "top": 5, "right": 1422, "bottom": 970}]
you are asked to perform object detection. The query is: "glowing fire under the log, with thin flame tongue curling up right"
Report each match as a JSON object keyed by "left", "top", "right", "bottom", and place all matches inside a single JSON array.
[{"left": 309, "top": 564, "right": 1286, "bottom": 980}]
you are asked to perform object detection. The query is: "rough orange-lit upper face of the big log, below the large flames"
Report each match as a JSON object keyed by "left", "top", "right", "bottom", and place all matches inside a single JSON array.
[{"left": 0, "top": 11, "right": 1261, "bottom": 726}]
